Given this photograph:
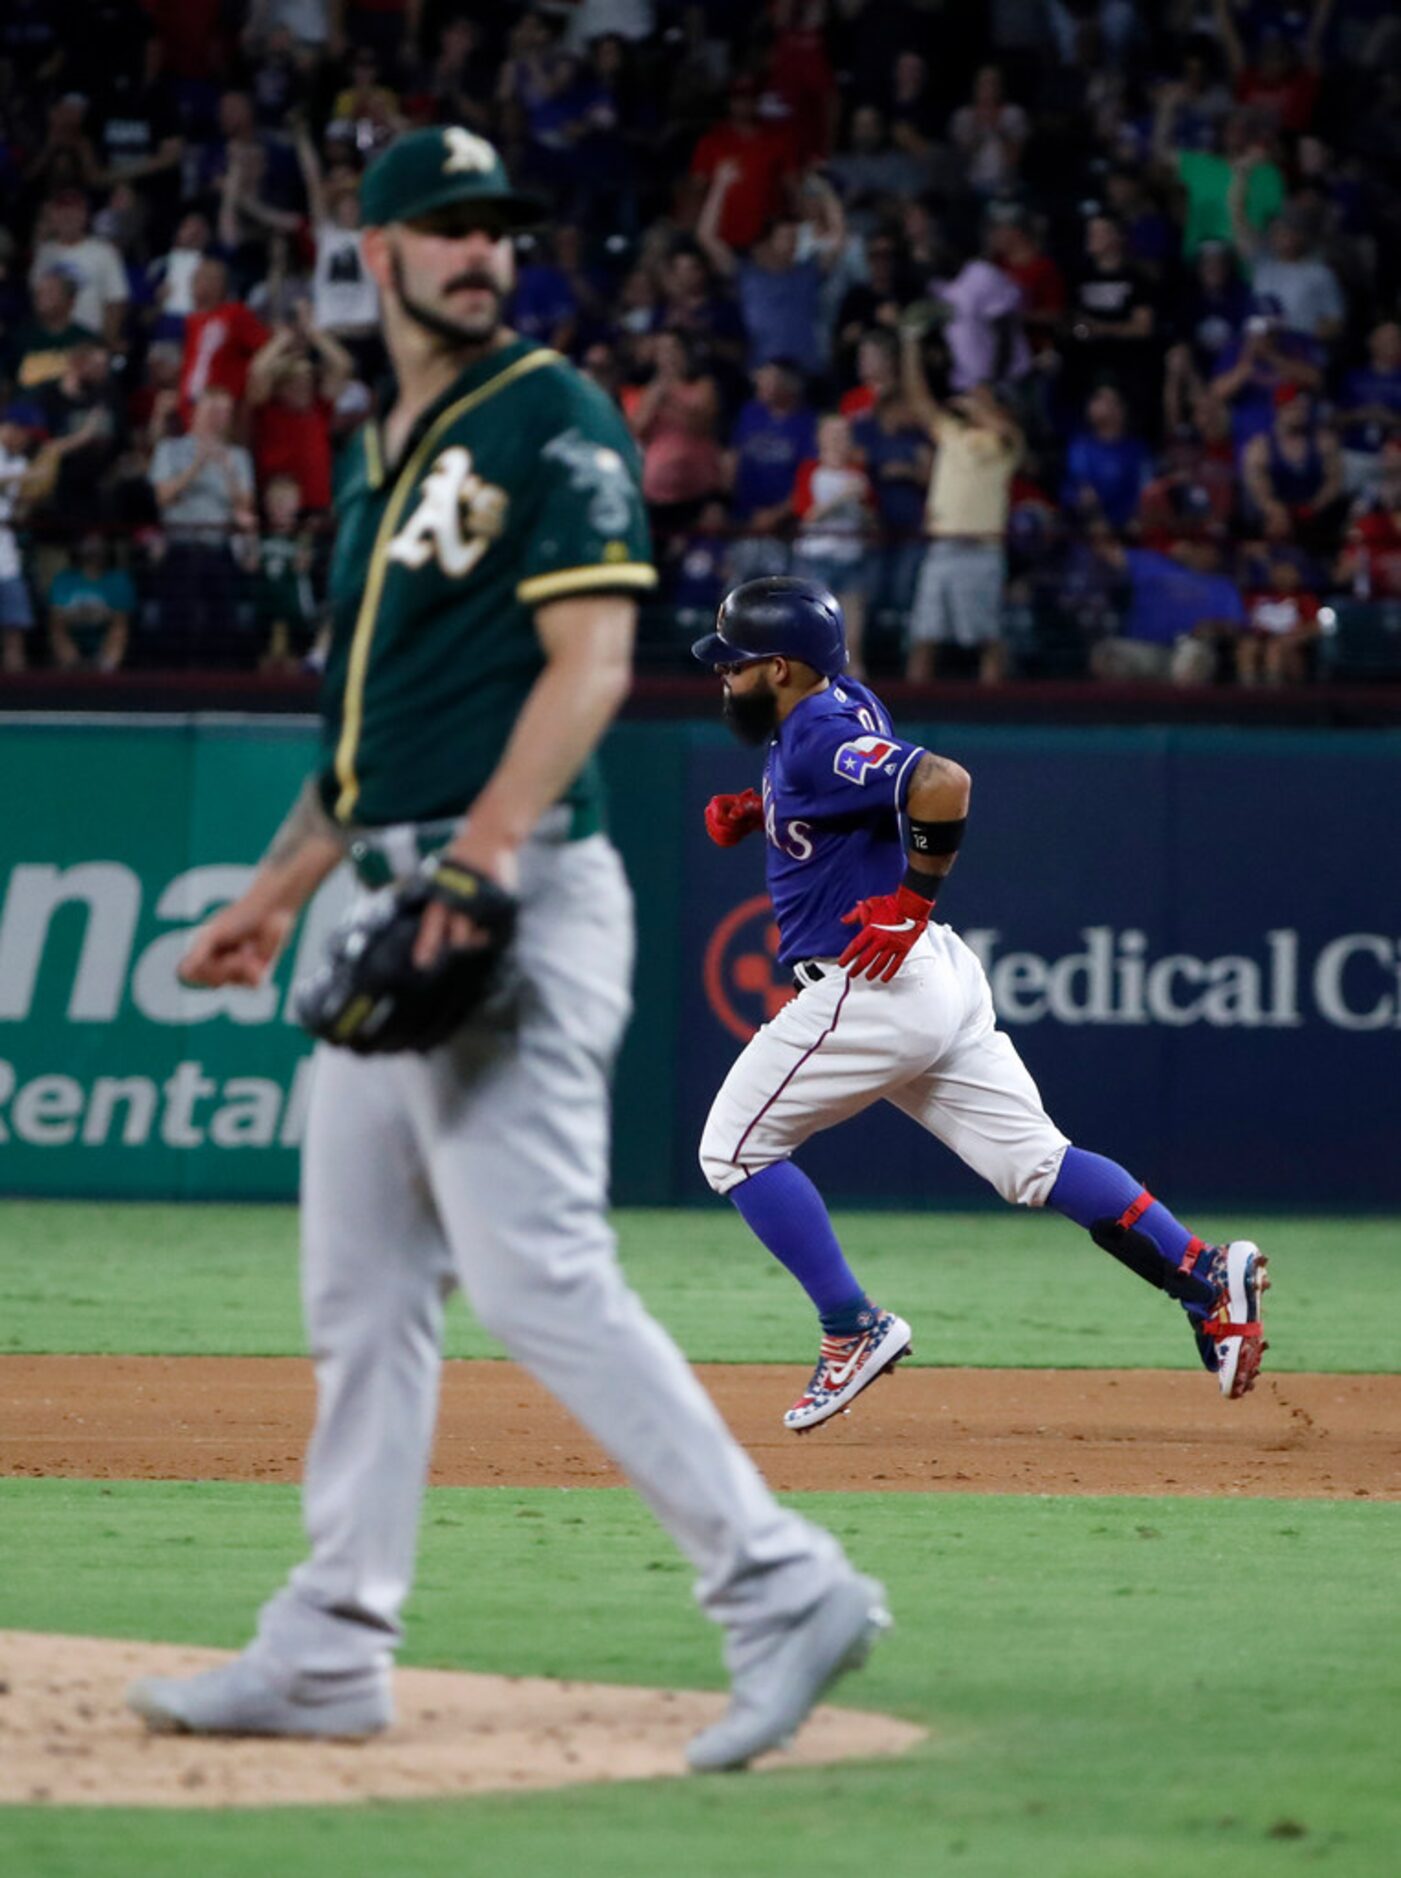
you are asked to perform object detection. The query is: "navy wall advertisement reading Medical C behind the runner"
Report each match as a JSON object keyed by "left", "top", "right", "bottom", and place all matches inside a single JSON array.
[{"left": 678, "top": 727, "right": 1401, "bottom": 1206}]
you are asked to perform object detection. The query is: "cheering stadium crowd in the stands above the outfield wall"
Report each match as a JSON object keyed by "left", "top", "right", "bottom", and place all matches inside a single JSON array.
[{"left": 0, "top": 0, "right": 1401, "bottom": 685}]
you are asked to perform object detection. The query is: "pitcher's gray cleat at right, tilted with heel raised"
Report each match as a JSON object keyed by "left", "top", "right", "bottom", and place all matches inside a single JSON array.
[{"left": 685, "top": 1572, "right": 890, "bottom": 1773}]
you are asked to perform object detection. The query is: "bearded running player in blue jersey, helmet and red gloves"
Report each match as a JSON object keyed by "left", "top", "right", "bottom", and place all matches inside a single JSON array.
[{"left": 693, "top": 577, "right": 1270, "bottom": 1431}]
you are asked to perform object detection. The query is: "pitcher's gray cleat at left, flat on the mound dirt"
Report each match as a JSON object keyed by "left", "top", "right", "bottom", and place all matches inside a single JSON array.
[{"left": 126, "top": 1655, "right": 394, "bottom": 1741}]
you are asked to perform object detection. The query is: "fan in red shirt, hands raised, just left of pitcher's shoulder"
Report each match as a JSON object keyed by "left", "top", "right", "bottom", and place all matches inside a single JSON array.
[{"left": 248, "top": 304, "right": 355, "bottom": 515}]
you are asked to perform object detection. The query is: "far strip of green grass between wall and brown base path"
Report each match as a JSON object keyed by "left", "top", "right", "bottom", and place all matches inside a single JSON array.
[{"left": 0, "top": 1200, "right": 1401, "bottom": 1371}]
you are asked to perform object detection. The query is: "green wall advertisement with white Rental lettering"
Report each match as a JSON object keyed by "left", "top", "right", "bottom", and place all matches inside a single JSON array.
[{"left": 0, "top": 719, "right": 347, "bottom": 1198}]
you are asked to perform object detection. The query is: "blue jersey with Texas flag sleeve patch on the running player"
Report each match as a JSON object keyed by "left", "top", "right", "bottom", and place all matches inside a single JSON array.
[{"left": 764, "top": 678, "right": 924, "bottom": 965}]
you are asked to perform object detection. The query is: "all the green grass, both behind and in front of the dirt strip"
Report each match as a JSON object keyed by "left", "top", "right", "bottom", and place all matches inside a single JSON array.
[{"left": 0, "top": 1202, "right": 1401, "bottom": 1878}]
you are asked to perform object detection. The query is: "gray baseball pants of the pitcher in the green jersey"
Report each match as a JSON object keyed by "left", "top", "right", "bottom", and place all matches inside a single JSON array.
[{"left": 254, "top": 836, "right": 845, "bottom": 1675}]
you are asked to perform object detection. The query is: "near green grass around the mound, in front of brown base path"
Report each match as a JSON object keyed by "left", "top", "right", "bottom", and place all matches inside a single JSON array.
[{"left": 0, "top": 1480, "right": 1401, "bottom": 1878}]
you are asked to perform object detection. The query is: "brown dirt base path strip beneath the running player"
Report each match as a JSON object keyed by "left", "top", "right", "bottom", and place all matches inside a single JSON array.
[{"left": 0, "top": 1356, "right": 1401, "bottom": 1499}]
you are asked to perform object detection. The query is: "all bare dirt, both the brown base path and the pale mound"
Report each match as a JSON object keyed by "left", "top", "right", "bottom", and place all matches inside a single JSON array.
[{"left": 0, "top": 1356, "right": 1401, "bottom": 1807}]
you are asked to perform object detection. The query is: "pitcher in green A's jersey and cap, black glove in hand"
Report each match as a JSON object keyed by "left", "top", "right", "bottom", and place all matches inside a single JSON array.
[{"left": 130, "top": 128, "right": 888, "bottom": 1769}]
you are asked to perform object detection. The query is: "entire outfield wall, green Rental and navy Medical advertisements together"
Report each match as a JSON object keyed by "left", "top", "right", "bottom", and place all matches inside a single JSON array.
[{"left": 0, "top": 719, "right": 1401, "bottom": 1206}]
